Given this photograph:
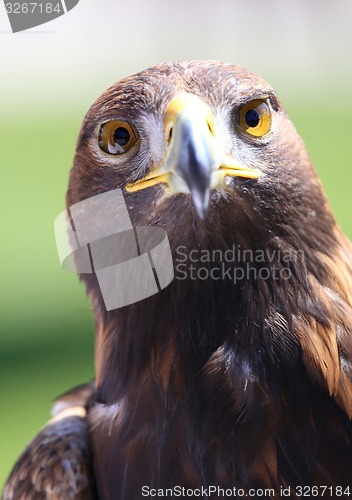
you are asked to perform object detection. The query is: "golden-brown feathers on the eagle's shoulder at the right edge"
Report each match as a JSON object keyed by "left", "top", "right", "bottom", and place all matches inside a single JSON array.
[{"left": 296, "top": 230, "right": 352, "bottom": 419}]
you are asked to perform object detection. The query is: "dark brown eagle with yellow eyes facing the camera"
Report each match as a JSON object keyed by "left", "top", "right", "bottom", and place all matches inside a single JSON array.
[{"left": 4, "top": 61, "right": 352, "bottom": 500}]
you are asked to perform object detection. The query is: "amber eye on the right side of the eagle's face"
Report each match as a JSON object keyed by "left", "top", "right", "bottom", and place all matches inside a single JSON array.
[{"left": 240, "top": 99, "right": 271, "bottom": 137}]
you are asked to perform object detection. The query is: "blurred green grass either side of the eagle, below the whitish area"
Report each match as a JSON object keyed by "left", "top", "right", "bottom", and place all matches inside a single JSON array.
[{"left": 0, "top": 92, "right": 352, "bottom": 488}]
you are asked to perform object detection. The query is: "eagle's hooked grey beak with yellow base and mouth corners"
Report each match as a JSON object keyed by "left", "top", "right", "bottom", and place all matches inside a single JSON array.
[{"left": 126, "top": 93, "right": 260, "bottom": 219}]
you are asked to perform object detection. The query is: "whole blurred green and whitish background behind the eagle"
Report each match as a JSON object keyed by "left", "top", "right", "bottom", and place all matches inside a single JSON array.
[{"left": 0, "top": 0, "right": 352, "bottom": 488}]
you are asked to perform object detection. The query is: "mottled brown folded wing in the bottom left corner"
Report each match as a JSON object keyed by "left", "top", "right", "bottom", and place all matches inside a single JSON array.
[{"left": 2, "top": 388, "right": 97, "bottom": 500}]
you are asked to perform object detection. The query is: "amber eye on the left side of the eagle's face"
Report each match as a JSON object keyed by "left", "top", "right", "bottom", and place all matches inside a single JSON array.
[{"left": 99, "top": 120, "right": 138, "bottom": 155}]
